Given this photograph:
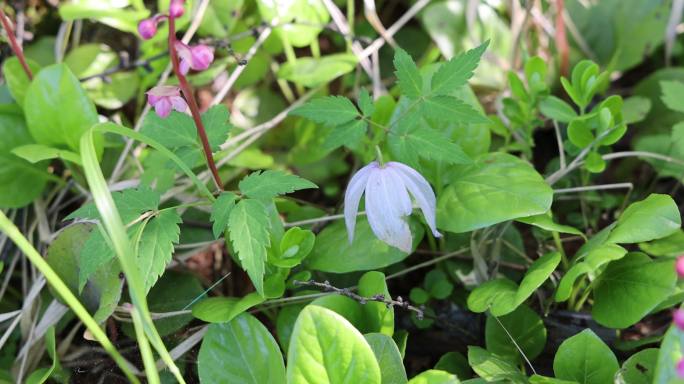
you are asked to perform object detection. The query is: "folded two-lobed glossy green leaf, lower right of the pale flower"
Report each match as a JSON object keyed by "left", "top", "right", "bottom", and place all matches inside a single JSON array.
[{"left": 468, "top": 252, "right": 560, "bottom": 316}]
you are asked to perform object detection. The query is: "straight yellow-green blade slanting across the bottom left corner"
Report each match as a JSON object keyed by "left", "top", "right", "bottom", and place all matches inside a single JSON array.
[{"left": 0, "top": 211, "right": 140, "bottom": 384}]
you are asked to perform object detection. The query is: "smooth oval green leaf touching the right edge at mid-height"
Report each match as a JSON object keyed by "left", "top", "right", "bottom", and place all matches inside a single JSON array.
[{"left": 608, "top": 193, "right": 682, "bottom": 243}]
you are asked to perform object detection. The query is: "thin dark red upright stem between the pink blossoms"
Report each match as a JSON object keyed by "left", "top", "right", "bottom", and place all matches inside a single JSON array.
[{"left": 169, "top": 17, "right": 223, "bottom": 191}]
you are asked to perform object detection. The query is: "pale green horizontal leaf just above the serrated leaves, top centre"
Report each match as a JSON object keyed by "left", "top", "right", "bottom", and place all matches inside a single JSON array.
[{"left": 278, "top": 53, "right": 358, "bottom": 88}]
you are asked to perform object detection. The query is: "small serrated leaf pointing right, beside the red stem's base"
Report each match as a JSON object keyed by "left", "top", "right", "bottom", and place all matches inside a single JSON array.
[{"left": 238, "top": 170, "right": 318, "bottom": 199}]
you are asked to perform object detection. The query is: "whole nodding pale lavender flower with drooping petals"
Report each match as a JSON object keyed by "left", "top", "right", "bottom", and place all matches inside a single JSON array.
[{"left": 344, "top": 161, "right": 441, "bottom": 253}]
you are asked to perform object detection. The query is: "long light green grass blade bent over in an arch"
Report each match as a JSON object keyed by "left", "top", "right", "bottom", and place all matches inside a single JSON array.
[{"left": 81, "top": 123, "right": 186, "bottom": 384}]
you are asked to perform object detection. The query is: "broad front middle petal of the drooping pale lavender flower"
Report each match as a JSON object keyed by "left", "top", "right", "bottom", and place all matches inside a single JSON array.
[{"left": 366, "top": 168, "right": 412, "bottom": 253}]
